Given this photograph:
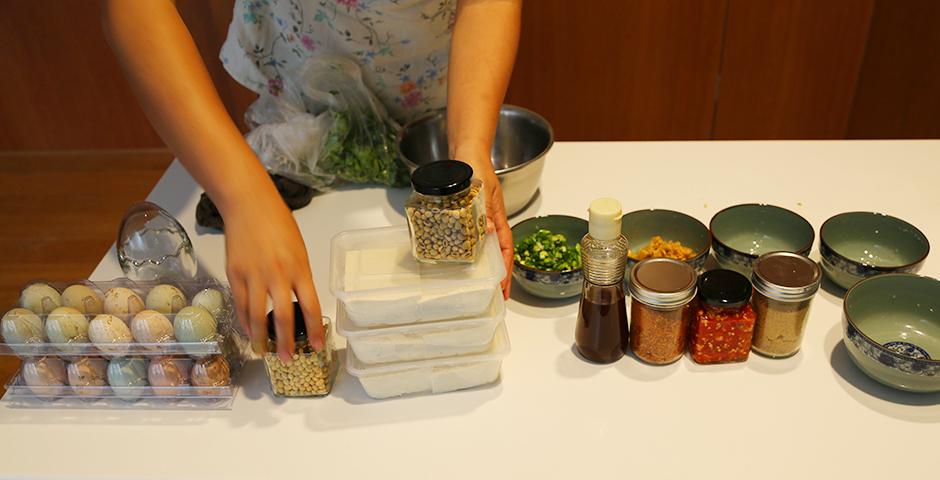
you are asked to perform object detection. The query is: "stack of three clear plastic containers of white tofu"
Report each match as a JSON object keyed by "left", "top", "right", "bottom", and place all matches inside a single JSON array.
[{"left": 331, "top": 226, "right": 509, "bottom": 398}]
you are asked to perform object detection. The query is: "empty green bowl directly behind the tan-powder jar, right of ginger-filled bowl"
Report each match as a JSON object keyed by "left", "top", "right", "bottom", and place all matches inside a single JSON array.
[{"left": 709, "top": 203, "right": 816, "bottom": 278}]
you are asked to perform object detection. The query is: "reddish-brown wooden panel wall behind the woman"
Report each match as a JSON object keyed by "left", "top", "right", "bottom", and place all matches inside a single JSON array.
[{"left": 0, "top": 0, "right": 940, "bottom": 150}]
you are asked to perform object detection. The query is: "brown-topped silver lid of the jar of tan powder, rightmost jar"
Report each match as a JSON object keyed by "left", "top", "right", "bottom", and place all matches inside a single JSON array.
[{"left": 751, "top": 252, "right": 822, "bottom": 302}]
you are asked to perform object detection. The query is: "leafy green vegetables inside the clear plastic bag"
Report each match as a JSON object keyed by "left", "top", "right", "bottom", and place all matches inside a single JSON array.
[{"left": 317, "top": 110, "right": 409, "bottom": 187}]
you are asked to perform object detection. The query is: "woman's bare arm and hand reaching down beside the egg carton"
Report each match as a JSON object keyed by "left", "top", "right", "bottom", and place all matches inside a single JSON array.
[{"left": 102, "top": 0, "right": 323, "bottom": 360}]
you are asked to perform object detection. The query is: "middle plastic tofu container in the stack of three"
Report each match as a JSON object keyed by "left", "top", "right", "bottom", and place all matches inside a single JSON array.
[{"left": 336, "top": 292, "right": 506, "bottom": 364}]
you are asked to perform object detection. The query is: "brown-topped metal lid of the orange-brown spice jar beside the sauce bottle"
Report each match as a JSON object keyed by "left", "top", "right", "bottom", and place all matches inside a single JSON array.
[{"left": 630, "top": 258, "right": 697, "bottom": 308}]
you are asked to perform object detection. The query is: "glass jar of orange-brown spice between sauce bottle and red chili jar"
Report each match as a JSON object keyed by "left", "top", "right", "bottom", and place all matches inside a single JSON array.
[{"left": 630, "top": 258, "right": 697, "bottom": 365}]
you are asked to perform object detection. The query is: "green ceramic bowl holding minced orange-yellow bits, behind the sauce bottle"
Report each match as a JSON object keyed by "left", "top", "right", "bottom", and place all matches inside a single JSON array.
[{"left": 620, "top": 209, "right": 712, "bottom": 273}]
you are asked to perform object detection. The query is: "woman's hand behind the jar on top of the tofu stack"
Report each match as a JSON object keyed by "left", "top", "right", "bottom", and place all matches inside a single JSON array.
[{"left": 454, "top": 147, "right": 514, "bottom": 298}]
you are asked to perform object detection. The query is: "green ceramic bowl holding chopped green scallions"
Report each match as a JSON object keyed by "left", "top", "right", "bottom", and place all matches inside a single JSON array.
[{"left": 512, "top": 215, "right": 588, "bottom": 299}]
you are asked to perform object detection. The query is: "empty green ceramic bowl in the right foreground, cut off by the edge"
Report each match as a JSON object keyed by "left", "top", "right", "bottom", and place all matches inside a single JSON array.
[{"left": 842, "top": 273, "right": 940, "bottom": 392}]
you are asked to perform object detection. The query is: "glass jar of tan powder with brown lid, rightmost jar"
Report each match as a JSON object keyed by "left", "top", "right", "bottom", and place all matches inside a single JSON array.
[{"left": 751, "top": 252, "right": 822, "bottom": 358}]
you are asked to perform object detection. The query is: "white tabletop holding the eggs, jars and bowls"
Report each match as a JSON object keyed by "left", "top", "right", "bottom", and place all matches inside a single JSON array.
[{"left": 0, "top": 141, "right": 940, "bottom": 480}]
